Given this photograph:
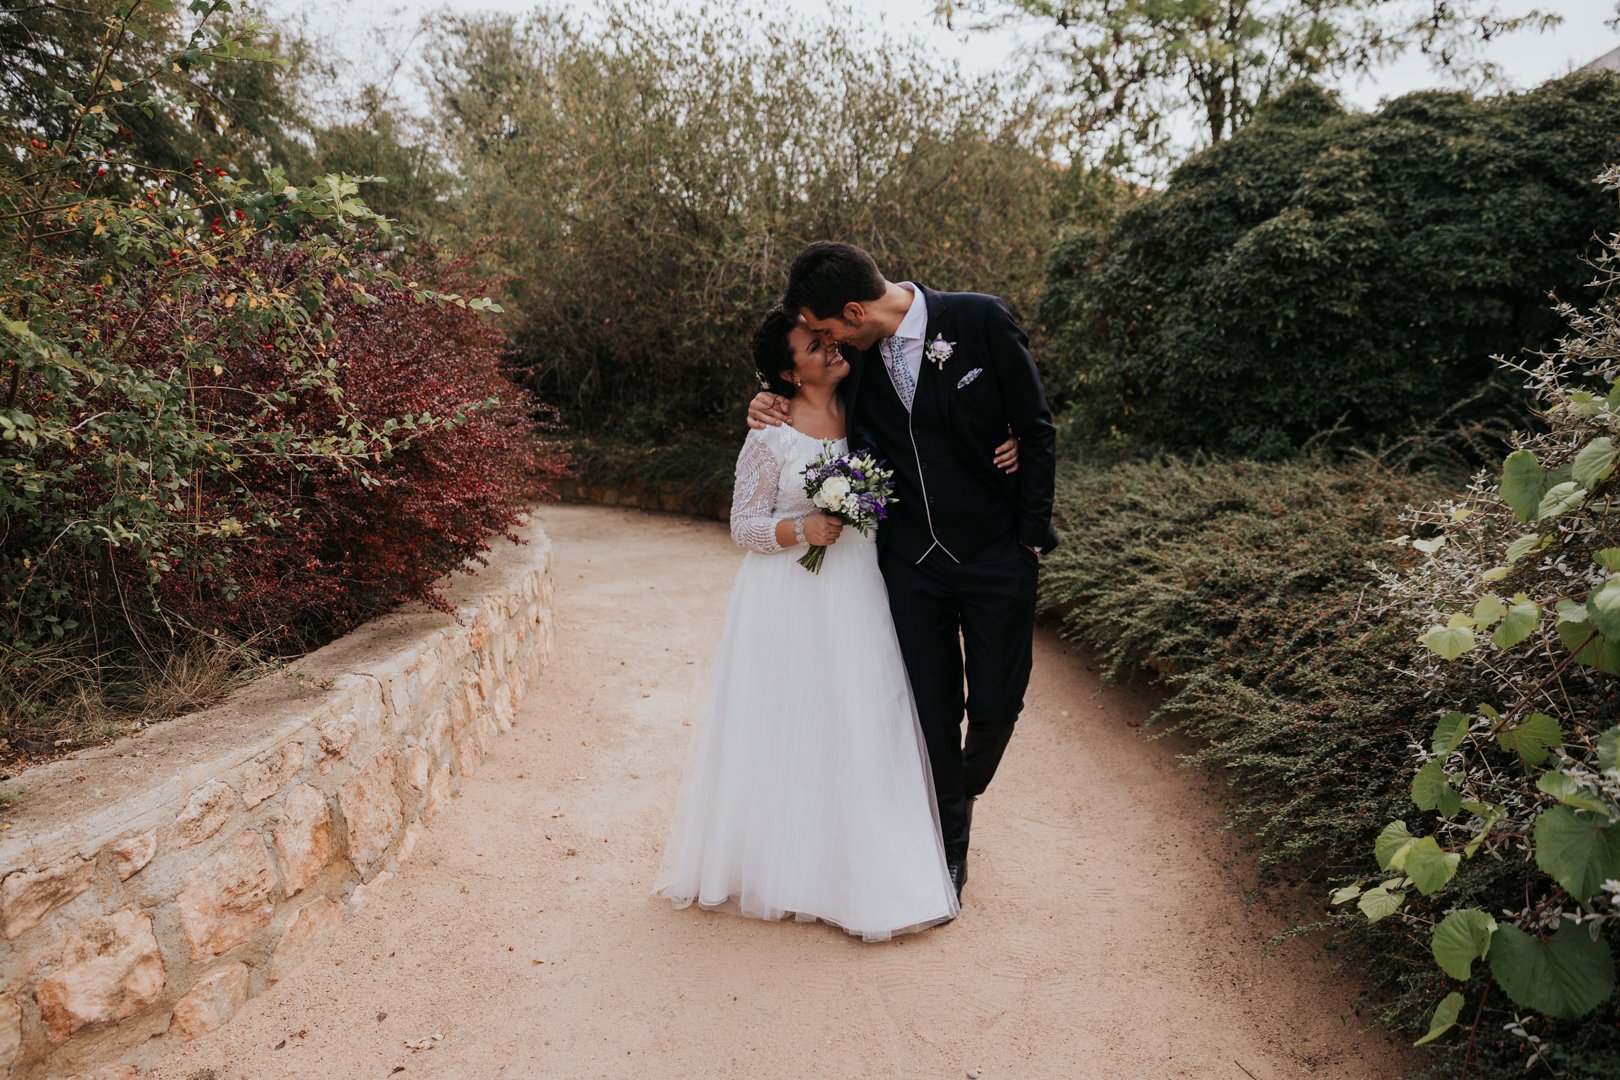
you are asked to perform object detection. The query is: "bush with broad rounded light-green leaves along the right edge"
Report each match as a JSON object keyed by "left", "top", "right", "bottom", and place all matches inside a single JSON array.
[{"left": 1335, "top": 168, "right": 1620, "bottom": 1075}]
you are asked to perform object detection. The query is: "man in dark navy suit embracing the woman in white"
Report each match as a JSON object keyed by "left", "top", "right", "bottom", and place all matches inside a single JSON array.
[{"left": 748, "top": 241, "right": 1058, "bottom": 897}]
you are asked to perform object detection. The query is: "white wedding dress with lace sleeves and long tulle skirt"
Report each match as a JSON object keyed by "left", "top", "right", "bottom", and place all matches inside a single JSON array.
[{"left": 654, "top": 426, "right": 957, "bottom": 941}]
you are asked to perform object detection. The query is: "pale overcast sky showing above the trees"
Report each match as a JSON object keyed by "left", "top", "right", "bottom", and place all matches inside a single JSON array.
[{"left": 275, "top": 0, "right": 1620, "bottom": 127}]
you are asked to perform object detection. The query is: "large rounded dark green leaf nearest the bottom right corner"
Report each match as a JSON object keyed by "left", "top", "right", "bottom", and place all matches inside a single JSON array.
[{"left": 1490, "top": 923, "right": 1615, "bottom": 1020}]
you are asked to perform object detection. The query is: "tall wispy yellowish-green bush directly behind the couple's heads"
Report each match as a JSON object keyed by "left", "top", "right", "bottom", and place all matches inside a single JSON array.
[{"left": 434, "top": 3, "right": 1082, "bottom": 443}]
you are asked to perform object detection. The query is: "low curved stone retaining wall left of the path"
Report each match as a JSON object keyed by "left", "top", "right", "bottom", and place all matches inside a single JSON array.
[{"left": 0, "top": 525, "right": 554, "bottom": 1080}]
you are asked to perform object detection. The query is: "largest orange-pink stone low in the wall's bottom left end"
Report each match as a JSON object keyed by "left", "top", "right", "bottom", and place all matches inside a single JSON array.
[{"left": 34, "top": 908, "right": 164, "bottom": 1043}]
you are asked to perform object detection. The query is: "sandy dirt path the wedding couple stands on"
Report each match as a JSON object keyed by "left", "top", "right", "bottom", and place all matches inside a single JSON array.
[{"left": 149, "top": 507, "right": 1405, "bottom": 1080}]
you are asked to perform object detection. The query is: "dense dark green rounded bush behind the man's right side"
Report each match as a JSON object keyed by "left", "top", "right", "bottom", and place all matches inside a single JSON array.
[{"left": 1037, "top": 74, "right": 1620, "bottom": 458}]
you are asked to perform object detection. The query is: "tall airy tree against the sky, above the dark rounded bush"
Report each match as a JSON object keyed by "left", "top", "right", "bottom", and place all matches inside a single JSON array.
[{"left": 935, "top": 0, "right": 1560, "bottom": 178}]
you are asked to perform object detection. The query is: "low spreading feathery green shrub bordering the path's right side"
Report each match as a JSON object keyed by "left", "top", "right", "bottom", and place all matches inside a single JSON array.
[{"left": 1042, "top": 457, "right": 1620, "bottom": 1080}]
